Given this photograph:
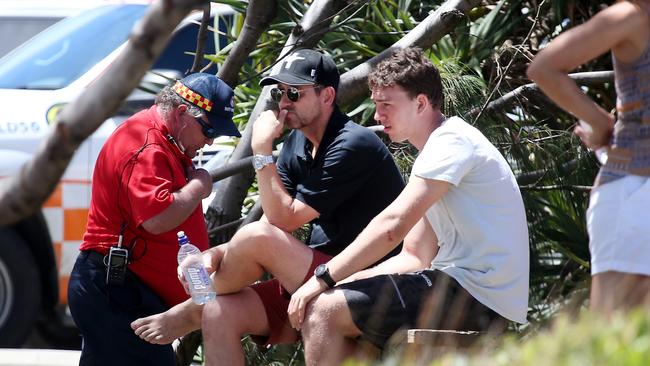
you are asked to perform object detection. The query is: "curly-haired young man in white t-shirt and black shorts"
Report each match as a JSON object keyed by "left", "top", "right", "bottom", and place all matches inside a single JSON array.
[{"left": 289, "top": 48, "right": 529, "bottom": 365}]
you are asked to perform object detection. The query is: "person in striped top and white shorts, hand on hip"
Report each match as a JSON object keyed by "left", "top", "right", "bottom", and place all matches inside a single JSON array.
[{"left": 528, "top": 0, "right": 650, "bottom": 315}]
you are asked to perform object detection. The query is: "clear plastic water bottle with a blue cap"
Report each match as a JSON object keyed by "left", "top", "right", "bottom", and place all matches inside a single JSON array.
[{"left": 176, "top": 231, "right": 217, "bottom": 305}]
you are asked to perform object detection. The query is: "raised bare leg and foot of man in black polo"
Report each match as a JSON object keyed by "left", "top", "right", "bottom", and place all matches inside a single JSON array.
[{"left": 131, "top": 222, "right": 313, "bottom": 344}]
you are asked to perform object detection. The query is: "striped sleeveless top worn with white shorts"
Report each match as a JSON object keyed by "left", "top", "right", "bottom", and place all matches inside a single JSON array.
[{"left": 594, "top": 15, "right": 650, "bottom": 187}]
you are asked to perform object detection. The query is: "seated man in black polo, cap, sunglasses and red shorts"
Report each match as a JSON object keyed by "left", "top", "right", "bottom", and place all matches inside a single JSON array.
[{"left": 132, "top": 49, "right": 404, "bottom": 365}]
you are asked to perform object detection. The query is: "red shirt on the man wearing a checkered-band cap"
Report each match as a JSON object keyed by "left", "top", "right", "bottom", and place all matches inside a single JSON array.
[{"left": 80, "top": 106, "right": 208, "bottom": 306}]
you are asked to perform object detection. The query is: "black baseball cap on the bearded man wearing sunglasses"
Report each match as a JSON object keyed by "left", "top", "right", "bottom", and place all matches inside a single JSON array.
[{"left": 260, "top": 49, "right": 340, "bottom": 90}]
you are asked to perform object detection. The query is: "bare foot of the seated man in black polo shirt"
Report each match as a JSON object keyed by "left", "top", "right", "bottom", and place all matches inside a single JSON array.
[{"left": 131, "top": 299, "right": 203, "bottom": 344}]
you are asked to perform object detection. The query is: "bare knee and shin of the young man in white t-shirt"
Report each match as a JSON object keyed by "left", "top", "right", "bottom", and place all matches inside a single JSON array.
[{"left": 302, "top": 290, "right": 361, "bottom": 366}]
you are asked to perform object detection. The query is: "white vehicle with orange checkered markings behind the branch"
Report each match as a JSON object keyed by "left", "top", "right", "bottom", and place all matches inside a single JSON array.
[{"left": 0, "top": 4, "right": 234, "bottom": 347}]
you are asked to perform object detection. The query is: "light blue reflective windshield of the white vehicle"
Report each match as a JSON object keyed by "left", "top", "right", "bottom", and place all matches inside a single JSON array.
[{"left": 0, "top": 5, "right": 146, "bottom": 90}]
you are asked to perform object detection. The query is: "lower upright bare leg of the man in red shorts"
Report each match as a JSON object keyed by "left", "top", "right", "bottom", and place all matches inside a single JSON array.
[{"left": 202, "top": 288, "right": 269, "bottom": 365}]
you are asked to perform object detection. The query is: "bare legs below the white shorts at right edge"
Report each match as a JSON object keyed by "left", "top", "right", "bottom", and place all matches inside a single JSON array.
[{"left": 589, "top": 271, "right": 650, "bottom": 316}]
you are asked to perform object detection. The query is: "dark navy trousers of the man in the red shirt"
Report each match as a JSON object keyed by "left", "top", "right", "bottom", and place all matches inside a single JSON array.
[{"left": 68, "top": 251, "right": 175, "bottom": 366}]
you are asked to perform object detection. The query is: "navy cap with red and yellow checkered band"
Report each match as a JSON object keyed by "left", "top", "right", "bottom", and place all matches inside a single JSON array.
[{"left": 172, "top": 72, "right": 241, "bottom": 137}]
